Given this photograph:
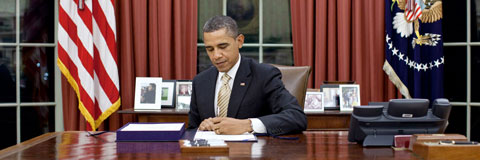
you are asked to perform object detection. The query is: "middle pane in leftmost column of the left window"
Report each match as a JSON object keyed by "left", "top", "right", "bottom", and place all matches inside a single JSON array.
[{"left": 0, "top": 47, "right": 17, "bottom": 102}]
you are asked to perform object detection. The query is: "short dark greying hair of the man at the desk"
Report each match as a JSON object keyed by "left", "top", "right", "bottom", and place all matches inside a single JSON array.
[{"left": 203, "top": 15, "right": 238, "bottom": 38}]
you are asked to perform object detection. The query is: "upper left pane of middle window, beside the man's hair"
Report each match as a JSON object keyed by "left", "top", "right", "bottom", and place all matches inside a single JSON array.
[{"left": 197, "top": 0, "right": 223, "bottom": 43}]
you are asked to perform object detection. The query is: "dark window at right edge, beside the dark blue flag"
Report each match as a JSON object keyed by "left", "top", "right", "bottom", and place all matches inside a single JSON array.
[{"left": 442, "top": 0, "right": 480, "bottom": 141}]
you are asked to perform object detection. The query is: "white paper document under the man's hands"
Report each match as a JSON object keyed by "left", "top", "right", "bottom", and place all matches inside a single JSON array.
[{"left": 193, "top": 131, "right": 257, "bottom": 142}]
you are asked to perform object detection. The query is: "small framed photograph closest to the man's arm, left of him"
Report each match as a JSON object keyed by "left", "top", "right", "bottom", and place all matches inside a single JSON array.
[{"left": 176, "top": 80, "right": 193, "bottom": 109}]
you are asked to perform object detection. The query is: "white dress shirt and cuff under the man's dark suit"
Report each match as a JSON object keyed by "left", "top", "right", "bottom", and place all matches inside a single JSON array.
[{"left": 214, "top": 55, "right": 267, "bottom": 133}]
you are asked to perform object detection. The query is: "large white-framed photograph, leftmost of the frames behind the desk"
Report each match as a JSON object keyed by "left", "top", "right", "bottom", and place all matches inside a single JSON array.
[{"left": 133, "top": 77, "right": 162, "bottom": 110}]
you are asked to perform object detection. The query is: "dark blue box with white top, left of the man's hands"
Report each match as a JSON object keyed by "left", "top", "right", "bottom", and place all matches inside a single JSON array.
[{"left": 117, "top": 123, "right": 185, "bottom": 142}]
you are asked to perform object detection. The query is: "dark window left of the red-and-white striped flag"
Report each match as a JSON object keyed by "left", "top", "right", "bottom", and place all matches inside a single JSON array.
[{"left": 0, "top": 0, "right": 63, "bottom": 149}]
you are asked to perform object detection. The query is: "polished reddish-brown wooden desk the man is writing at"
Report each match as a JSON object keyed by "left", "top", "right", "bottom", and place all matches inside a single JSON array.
[{"left": 0, "top": 131, "right": 417, "bottom": 160}]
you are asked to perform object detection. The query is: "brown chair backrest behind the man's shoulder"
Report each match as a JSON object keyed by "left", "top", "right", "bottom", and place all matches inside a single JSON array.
[{"left": 272, "top": 64, "right": 310, "bottom": 108}]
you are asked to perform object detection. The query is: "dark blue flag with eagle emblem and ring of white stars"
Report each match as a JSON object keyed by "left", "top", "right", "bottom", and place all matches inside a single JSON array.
[{"left": 383, "top": 0, "right": 445, "bottom": 100}]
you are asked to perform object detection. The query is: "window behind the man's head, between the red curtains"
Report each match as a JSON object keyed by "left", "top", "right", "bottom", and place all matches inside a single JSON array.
[{"left": 197, "top": 0, "right": 293, "bottom": 73}]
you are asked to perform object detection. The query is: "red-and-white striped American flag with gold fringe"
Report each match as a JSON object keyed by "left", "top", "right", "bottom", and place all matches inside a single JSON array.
[{"left": 57, "top": 0, "right": 120, "bottom": 130}]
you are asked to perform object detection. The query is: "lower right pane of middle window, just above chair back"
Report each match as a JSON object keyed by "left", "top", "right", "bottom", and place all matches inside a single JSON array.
[{"left": 263, "top": 47, "right": 293, "bottom": 66}]
